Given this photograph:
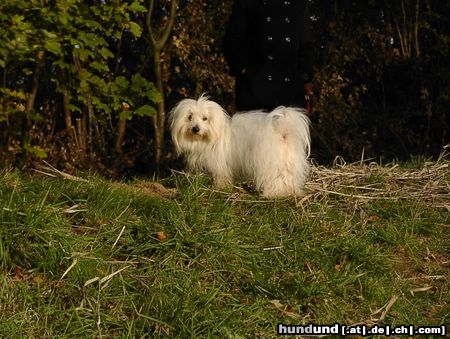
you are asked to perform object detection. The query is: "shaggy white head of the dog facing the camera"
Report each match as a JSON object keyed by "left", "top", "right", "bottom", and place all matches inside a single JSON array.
[{"left": 169, "top": 95, "right": 230, "bottom": 153}]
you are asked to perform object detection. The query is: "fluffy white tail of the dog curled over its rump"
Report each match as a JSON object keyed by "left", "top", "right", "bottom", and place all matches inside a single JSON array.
[{"left": 268, "top": 106, "right": 311, "bottom": 157}]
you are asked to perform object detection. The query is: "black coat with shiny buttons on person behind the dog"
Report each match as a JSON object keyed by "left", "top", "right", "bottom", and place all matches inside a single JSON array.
[{"left": 223, "top": 0, "right": 313, "bottom": 110}]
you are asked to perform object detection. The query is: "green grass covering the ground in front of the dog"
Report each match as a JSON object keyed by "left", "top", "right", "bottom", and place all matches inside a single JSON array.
[{"left": 0, "top": 164, "right": 450, "bottom": 338}]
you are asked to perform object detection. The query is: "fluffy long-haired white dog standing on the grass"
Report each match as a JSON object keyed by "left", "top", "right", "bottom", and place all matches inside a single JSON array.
[{"left": 169, "top": 96, "right": 310, "bottom": 197}]
